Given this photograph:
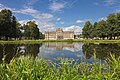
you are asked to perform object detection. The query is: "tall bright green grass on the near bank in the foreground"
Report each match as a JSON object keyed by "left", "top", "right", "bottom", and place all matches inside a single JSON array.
[{"left": 0, "top": 56, "right": 120, "bottom": 80}]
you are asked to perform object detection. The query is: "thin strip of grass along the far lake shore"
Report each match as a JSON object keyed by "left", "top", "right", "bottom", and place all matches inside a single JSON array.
[{"left": 0, "top": 40, "right": 120, "bottom": 44}]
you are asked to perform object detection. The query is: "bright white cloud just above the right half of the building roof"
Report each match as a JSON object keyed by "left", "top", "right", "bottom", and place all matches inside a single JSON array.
[{"left": 63, "top": 25, "right": 82, "bottom": 34}]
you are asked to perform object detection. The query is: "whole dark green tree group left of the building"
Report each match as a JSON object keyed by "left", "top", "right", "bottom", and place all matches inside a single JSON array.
[{"left": 0, "top": 9, "right": 44, "bottom": 40}]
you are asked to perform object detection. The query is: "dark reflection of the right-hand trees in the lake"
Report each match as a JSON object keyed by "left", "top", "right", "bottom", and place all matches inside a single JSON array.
[{"left": 82, "top": 44, "right": 120, "bottom": 60}]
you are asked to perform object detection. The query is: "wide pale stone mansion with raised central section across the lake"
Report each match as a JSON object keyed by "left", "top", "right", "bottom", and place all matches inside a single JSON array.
[{"left": 45, "top": 28, "right": 74, "bottom": 40}]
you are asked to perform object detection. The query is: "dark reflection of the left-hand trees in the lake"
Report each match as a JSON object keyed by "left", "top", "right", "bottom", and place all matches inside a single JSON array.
[{"left": 0, "top": 44, "right": 42, "bottom": 63}]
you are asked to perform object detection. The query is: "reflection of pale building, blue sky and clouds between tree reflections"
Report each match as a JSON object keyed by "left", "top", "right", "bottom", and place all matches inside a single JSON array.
[{"left": 38, "top": 42, "right": 83, "bottom": 60}]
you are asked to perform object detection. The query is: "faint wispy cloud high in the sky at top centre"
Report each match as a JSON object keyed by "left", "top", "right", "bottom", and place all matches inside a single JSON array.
[{"left": 49, "top": 2, "right": 66, "bottom": 11}]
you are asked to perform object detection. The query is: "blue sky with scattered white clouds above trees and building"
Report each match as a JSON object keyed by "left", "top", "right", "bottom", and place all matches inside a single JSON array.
[{"left": 0, "top": 0, "right": 120, "bottom": 34}]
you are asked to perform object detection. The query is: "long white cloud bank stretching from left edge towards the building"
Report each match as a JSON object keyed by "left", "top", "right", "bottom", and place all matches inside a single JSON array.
[{"left": 0, "top": 4, "right": 55, "bottom": 33}]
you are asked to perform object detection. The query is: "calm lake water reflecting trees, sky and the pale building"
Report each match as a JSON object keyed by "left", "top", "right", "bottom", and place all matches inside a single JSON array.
[{"left": 0, "top": 42, "right": 120, "bottom": 63}]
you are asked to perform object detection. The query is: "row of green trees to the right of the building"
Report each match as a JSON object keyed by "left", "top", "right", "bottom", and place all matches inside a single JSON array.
[{"left": 82, "top": 12, "right": 120, "bottom": 39}]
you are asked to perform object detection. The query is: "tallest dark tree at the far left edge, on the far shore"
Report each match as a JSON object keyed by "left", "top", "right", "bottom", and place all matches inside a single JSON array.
[{"left": 0, "top": 9, "right": 21, "bottom": 40}]
